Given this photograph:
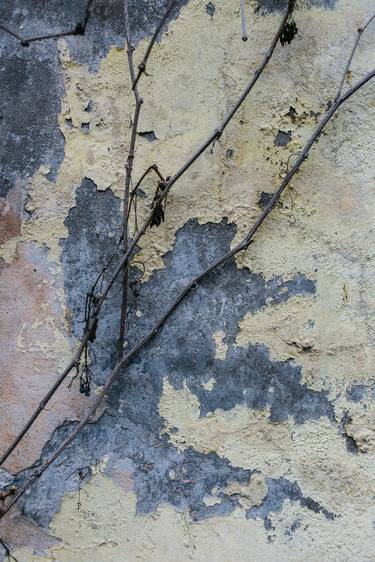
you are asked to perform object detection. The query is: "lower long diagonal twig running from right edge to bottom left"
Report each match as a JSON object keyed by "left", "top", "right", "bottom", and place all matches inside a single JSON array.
[{"left": 0, "top": 69, "right": 375, "bottom": 519}]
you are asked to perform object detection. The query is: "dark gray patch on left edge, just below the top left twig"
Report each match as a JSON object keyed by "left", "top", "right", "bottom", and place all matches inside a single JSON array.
[{"left": 0, "top": 43, "right": 64, "bottom": 197}]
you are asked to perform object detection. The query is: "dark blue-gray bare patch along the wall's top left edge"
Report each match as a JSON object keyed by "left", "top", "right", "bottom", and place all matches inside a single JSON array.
[{"left": 0, "top": 0, "right": 188, "bottom": 70}]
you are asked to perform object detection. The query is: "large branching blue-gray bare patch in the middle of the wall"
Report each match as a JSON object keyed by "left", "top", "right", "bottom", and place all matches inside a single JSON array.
[{"left": 13, "top": 179, "right": 332, "bottom": 525}]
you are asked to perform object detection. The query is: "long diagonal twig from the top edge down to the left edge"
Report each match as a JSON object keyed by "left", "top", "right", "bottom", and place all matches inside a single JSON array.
[{"left": 0, "top": 0, "right": 293, "bottom": 466}]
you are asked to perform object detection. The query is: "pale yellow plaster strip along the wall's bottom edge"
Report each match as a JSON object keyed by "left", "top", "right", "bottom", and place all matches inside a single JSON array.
[{"left": 15, "top": 474, "right": 375, "bottom": 562}]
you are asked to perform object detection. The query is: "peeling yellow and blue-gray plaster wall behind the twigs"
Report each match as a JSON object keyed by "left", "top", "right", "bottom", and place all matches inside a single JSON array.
[{"left": 0, "top": 0, "right": 375, "bottom": 562}]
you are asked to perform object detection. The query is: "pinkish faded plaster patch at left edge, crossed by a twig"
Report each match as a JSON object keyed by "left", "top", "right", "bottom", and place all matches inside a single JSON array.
[{"left": 0, "top": 243, "right": 94, "bottom": 472}]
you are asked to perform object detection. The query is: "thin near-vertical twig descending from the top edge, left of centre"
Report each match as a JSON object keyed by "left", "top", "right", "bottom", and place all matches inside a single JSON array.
[{"left": 117, "top": 0, "right": 143, "bottom": 359}]
